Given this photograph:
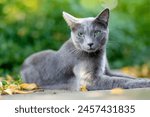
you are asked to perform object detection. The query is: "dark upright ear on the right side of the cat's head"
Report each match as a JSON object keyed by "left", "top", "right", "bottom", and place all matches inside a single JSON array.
[{"left": 96, "top": 8, "right": 109, "bottom": 24}]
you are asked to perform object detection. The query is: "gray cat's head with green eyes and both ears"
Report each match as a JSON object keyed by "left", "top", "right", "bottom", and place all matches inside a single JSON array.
[{"left": 63, "top": 9, "right": 109, "bottom": 53}]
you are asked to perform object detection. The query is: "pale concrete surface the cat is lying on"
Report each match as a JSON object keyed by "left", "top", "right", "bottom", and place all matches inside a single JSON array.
[{"left": 0, "top": 88, "right": 150, "bottom": 100}]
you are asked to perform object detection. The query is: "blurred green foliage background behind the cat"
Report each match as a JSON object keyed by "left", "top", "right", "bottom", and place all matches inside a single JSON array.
[{"left": 0, "top": 0, "right": 150, "bottom": 75}]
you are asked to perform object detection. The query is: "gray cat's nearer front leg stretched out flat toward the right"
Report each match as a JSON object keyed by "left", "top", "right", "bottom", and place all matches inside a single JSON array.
[{"left": 87, "top": 75, "right": 150, "bottom": 90}]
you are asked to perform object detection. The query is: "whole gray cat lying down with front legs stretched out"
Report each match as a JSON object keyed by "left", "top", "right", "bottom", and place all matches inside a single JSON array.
[{"left": 21, "top": 9, "right": 150, "bottom": 91}]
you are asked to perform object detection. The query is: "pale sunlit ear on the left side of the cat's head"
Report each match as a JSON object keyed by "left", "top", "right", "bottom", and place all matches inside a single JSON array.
[{"left": 63, "top": 11, "right": 78, "bottom": 28}]
